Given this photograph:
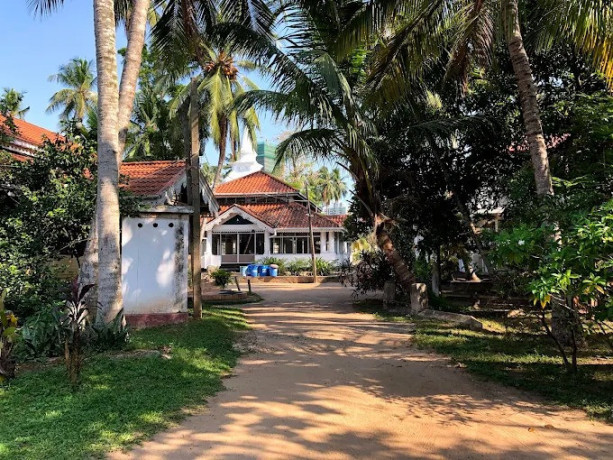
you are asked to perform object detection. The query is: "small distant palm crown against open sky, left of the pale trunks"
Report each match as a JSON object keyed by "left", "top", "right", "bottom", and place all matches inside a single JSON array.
[{"left": 47, "top": 58, "right": 97, "bottom": 123}]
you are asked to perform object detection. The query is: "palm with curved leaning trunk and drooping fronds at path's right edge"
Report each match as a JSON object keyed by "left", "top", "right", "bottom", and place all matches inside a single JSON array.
[{"left": 230, "top": 0, "right": 414, "bottom": 292}]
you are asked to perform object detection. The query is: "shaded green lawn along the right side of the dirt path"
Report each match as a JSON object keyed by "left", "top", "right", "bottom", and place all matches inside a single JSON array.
[{"left": 356, "top": 303, "right": 613, "bottom": 422}]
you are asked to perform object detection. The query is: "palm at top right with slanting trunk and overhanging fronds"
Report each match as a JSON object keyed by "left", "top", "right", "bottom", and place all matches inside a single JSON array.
[{"left": 338, "top": 0, "right": 613, "bottom": 196}]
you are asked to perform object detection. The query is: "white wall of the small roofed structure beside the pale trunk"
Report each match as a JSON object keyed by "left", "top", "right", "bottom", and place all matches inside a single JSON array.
[{"left": 121, "top": 214, "right": 189, "bottom": 315}]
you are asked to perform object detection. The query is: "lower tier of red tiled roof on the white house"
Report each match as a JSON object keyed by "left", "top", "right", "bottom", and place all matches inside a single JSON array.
[{"left": 209, "top": 202, "right": 341, "bottom": 229}]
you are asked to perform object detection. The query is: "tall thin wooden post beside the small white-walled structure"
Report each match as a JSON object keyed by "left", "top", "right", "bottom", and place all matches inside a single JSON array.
[{"left": 187, "top": 78, "right": 202, "bottom": 319}]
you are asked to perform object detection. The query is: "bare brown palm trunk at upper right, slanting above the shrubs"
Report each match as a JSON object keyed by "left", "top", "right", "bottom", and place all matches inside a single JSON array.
[{"left": 504, "top": 0, "right": 553, "bottom": 196}]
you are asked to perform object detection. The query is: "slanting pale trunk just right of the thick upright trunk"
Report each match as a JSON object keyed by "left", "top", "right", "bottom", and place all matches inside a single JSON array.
[{"left": 118, "top": 0, "right": 151, "bottom": 156}]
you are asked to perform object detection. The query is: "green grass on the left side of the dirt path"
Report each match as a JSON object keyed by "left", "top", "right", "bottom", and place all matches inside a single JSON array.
[{"left": 0, "top": 308, "right": 247, "bottom": 459}]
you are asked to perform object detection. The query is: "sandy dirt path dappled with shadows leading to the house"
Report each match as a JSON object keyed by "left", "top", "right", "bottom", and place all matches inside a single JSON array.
[{"left": 114, "top": 285, "right": 613, "bottom": 460}]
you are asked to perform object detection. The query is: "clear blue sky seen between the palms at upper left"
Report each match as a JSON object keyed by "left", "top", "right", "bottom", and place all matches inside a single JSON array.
[{"left": 0, "top": 0, "right": 287, "bottom": 163}]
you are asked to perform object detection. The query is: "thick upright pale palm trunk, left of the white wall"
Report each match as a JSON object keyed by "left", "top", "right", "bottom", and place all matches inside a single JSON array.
[{"left": 94, "top": 0, "right": 122, "bottom": 323}]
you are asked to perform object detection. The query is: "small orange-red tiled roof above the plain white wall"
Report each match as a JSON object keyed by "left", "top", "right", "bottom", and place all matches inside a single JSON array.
[{"left": 119, "top": 160, "right": 185, "bottom": 196}]
